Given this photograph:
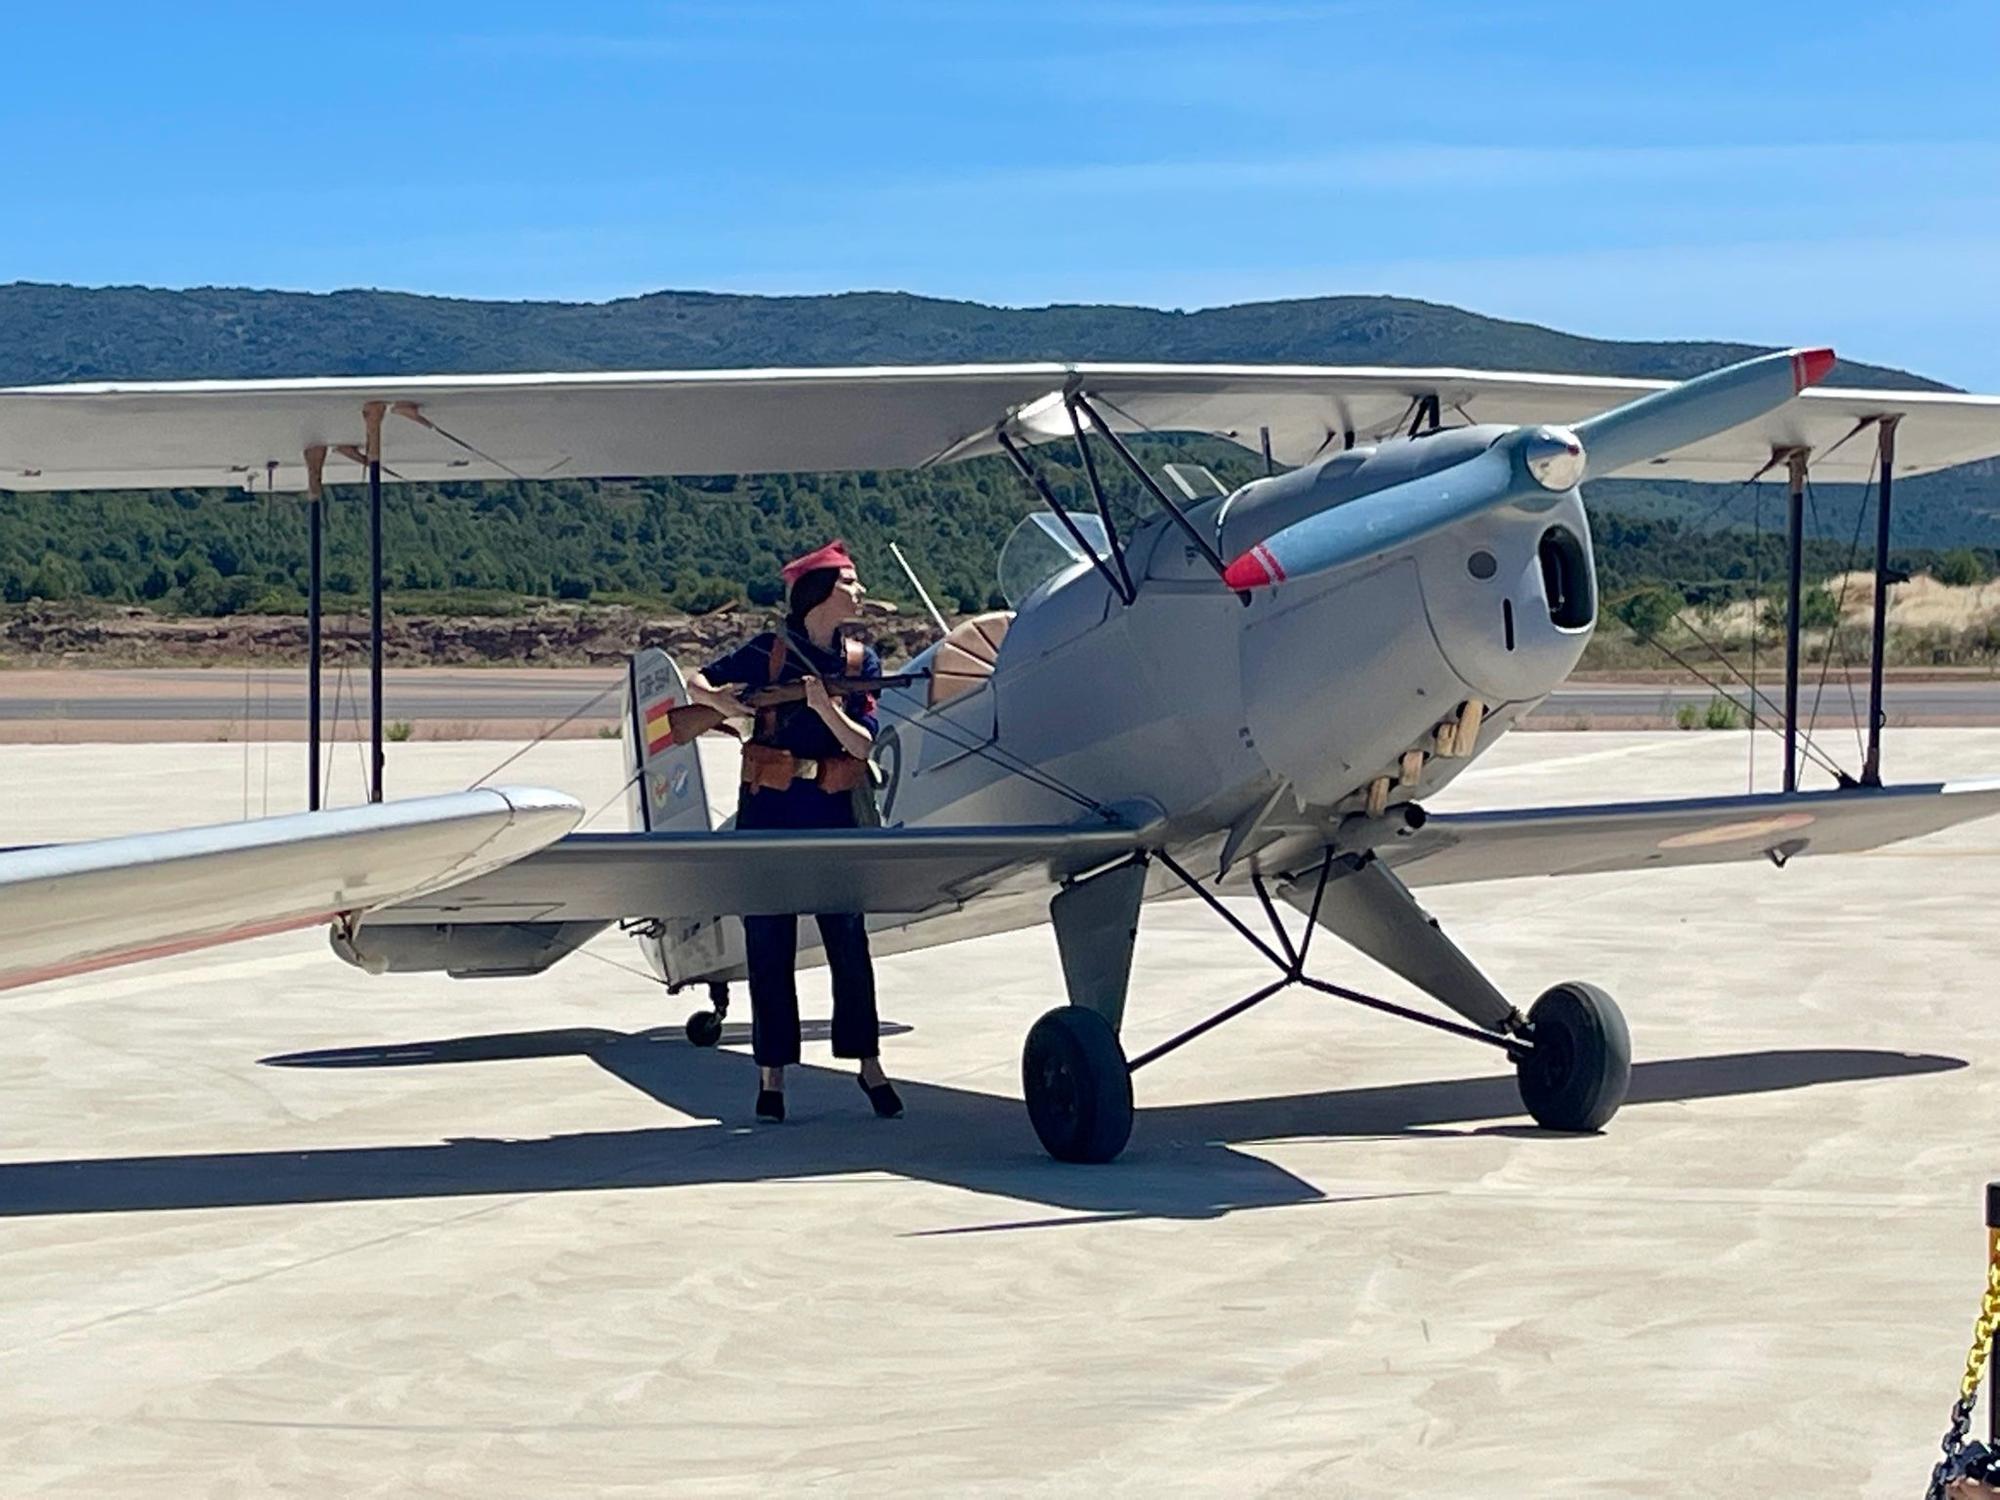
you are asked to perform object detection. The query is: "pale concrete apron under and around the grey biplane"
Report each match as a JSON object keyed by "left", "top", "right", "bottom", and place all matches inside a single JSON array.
[{"left": 0, "top": 730, "right": 2000, "bottom": 1498}]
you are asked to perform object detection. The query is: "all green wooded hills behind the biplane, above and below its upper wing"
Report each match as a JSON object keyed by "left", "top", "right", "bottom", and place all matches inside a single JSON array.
[{"left": 0, "top": 284, "right": 2000, "bottom": 634}]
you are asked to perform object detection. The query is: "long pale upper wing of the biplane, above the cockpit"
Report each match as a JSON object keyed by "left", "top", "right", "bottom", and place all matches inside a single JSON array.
[{"left": 0, "top": 364, "right": 2000, "bottom": 490}]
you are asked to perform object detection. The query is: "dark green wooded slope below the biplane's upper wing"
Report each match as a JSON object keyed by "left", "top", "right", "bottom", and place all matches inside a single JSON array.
[{"left": 0, "top": 438, "right": 1994, "bottom": 616}]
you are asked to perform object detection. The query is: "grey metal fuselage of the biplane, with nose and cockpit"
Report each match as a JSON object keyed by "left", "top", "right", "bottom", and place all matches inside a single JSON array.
[{"left": 648, "top": 428, "right": 1596, "bottom": 982}]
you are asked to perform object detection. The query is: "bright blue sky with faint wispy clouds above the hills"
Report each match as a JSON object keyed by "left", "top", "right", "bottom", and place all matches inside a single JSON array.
[{"left": 0, "top": 0, "right": 2000, "bottom": 390}]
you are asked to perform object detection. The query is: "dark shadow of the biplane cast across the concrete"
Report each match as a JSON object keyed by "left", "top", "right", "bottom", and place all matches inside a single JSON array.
[{"left": 0, "top": 1024, "right": 1966, "bottom": 1228}]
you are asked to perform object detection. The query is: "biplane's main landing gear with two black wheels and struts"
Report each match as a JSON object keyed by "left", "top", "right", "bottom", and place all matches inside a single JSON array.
[{"left": 1020, "top": 854, "right": 1632, "bottom": 1162}]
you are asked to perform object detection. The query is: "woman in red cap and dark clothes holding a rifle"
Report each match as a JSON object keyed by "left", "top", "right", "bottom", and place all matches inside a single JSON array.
[{"left": 688, "top": 542, "right": 902, "bottom": 1120}]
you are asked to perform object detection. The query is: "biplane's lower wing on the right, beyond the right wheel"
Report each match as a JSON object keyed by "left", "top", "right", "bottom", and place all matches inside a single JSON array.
[{"left": 1352, "top": 780, "right": 2000, "bottom": 886}]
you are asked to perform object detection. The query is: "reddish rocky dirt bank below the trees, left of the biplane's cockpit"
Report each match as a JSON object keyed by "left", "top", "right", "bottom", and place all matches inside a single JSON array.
[{"left": 0, "top": 604, "right": 934, "bottom": 668}]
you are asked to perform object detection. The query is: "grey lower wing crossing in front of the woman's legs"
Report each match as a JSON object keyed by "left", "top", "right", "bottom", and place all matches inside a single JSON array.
[{"left": 368, "top": 824, "right": 1148, "bottom": 928}]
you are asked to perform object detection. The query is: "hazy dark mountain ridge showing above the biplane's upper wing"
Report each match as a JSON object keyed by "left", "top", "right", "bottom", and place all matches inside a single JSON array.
[{"left": 0, "top": 282, "right": 1950, "bottom": 390}]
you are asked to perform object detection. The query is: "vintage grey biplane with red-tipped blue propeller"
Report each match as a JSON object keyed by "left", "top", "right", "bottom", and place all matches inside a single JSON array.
[{"left": 0, "top": 350, "right": 2000, "bottom": 1162}]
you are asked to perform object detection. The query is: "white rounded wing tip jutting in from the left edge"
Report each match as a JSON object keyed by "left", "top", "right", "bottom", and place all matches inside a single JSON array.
[{"left": 0, "top": 786, "right": 584, "bottom": 990}]
